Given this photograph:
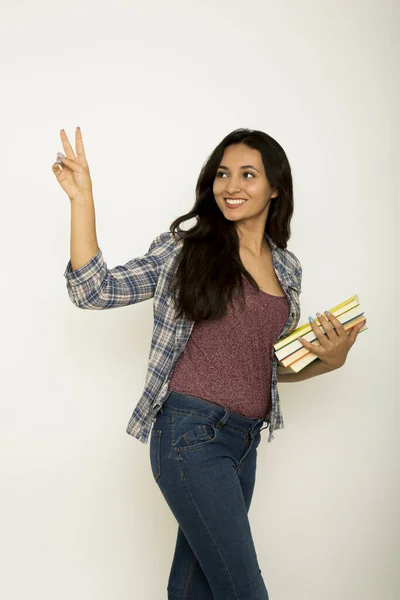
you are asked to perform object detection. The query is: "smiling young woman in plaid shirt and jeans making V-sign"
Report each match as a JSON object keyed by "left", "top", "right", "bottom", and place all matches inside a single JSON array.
[{"left": 53, "top": 128, "right": 365, "bottom": 600}]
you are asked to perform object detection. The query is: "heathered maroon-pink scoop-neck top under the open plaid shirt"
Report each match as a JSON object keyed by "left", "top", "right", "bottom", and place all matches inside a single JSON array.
[{"left": 169, "top": 277, "right": 289, "bottom": 419}]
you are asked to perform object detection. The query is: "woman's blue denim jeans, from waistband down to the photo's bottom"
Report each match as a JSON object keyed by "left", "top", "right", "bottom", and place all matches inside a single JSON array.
[{"left": 150, "top": 390, "right": 268, "bottom": 600}]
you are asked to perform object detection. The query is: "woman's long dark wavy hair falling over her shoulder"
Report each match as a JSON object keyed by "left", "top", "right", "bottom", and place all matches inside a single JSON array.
[{"left": 169, "top": 129, "right": 293, "bottom": 321}]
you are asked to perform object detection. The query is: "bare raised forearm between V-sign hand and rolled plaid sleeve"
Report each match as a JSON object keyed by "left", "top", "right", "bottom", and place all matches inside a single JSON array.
[{"left": 70, "top": 195, "right": 99, "bottom": 271}]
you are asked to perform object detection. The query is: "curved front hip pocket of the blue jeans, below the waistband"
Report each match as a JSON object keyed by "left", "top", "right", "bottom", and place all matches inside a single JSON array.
[{"left": 172, "top": 414, "right": 218, "bottom": 452}]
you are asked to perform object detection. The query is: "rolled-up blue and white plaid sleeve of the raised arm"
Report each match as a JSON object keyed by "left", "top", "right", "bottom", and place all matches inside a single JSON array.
[{"left": 64, "top": 232, "right": 173, "bottom": 310}]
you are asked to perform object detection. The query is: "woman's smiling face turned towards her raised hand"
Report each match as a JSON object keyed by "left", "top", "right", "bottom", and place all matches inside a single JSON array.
[{"left": 213, "top": 143, "right": 279, "bottom": 224}]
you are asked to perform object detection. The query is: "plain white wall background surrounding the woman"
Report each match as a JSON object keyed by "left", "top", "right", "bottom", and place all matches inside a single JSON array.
[{"left": 0, "top": 0, "right": 400, "bottom": 600}]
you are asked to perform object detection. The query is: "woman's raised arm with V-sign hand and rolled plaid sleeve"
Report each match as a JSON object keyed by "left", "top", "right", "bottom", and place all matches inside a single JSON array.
[{"left": 53, "top": 128, "right": 173, "bottom": 310}]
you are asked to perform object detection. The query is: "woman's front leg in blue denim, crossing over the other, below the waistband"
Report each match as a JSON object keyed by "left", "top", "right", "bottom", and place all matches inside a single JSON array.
[{"left": 150, "top": 413, "right": 268, "bottom": 600}]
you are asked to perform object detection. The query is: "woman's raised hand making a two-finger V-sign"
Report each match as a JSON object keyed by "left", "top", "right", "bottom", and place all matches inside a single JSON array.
[{"left": 53, "top": 128, "right": 93, "bottom": 200}]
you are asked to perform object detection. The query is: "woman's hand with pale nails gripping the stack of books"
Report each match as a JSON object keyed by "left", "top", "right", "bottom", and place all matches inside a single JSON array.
[{"left": 299, "top": 312, "right": 367, "bottom": 371}]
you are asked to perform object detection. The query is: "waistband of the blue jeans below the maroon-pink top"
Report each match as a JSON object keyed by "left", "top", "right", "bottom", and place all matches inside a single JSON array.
[{"left": 160, "top": 390, "right": 267, "bottom": 434}]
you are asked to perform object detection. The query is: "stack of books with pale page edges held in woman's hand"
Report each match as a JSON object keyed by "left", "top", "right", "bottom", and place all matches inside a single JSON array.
[{"left": 274, "top": 295, "right": 368, "bottom": 373}]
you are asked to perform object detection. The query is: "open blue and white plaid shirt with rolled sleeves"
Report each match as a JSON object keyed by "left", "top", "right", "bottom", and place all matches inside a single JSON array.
[{"left": 64, "top": 231, "right": 302, "bottom": 443}]
